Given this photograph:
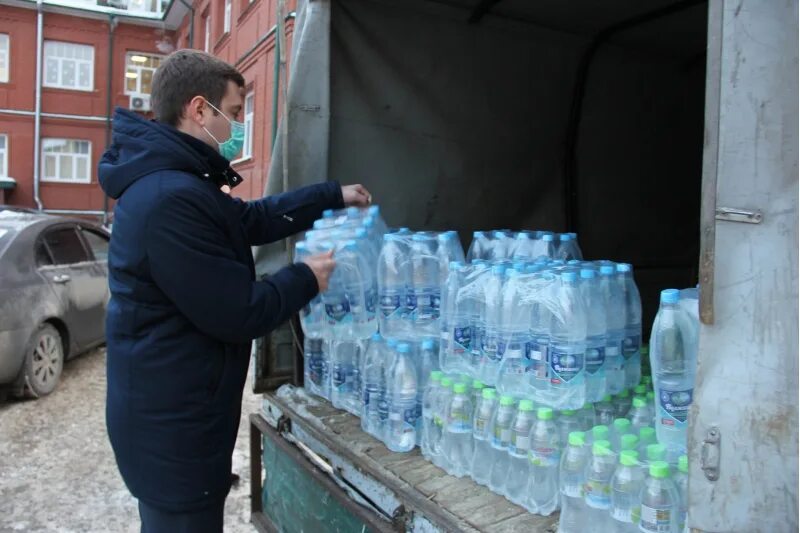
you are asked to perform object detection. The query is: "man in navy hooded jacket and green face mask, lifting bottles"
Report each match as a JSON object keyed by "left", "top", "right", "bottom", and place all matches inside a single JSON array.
[{"left": 99, "top": 50, "right": 370, "bottom": 533}]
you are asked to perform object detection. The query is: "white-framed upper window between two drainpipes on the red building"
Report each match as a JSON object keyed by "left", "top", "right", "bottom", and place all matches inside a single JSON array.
[{"left": 44, "top": 41, "right": 94, "bottom": 91}]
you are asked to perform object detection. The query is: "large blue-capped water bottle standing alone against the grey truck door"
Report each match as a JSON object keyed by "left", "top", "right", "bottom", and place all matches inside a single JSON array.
[{"left": 650, "top": 289, "right": 697, "bottom": 455}]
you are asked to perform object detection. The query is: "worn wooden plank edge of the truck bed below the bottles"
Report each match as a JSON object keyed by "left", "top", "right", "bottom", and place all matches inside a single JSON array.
[{"left": 268, "top": 389, "right": 558, "bottom": 533}]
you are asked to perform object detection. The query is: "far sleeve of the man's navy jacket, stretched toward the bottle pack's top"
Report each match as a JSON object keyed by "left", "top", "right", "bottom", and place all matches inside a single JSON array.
[{"left": 233, "top": 181, "right": 344, "bottom": 246}]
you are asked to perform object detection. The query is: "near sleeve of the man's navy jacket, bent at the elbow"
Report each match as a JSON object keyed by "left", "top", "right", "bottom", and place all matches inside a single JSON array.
[{"left": 145, "top": 189, "right": 318, "bottom": 343}]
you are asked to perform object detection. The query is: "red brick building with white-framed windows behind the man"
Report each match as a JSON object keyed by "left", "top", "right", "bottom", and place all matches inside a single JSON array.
[{"left": 0, "top": 0, "right": 294, "bottom": 221}]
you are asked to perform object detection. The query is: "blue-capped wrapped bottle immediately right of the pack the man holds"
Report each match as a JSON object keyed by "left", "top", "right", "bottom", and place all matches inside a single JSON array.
[{"left": 378, "top": 233, "right": 410, "bottom": 337}]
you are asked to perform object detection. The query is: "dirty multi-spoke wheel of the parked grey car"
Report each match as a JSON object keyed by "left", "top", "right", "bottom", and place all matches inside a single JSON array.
[{"left": 25, "top": 324, "right": 64, "bottom": 398}]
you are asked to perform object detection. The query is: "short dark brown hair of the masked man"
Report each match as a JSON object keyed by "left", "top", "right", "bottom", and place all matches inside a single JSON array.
[{"left": 152, "top": 50, "right": 244, "bottom": 126}]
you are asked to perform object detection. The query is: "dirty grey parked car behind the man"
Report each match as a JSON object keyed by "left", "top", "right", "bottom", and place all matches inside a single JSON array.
[{"left": 0, "top": 210, "right": 109, "bottom": 397}]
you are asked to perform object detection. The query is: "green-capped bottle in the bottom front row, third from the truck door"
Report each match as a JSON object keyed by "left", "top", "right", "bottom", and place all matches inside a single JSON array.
[{"left": 609, "top": 450, "right": 644, "bottom": 533}]
